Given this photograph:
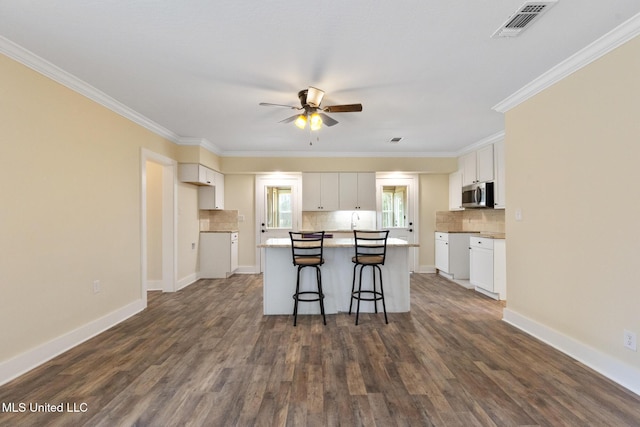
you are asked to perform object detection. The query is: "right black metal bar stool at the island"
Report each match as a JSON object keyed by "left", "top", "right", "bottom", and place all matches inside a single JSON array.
[{"left": 349, "top": 230, "right": 389, "bottom": 325}]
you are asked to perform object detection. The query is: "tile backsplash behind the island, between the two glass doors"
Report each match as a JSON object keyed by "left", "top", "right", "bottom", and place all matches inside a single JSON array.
[{"left": 302, "top": 211, "right": 376, "bottom": 231}]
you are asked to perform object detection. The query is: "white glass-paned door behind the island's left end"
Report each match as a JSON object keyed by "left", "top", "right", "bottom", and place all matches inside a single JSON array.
[{"left": 255, "top": 175, "right": 302, "bottom": 272}]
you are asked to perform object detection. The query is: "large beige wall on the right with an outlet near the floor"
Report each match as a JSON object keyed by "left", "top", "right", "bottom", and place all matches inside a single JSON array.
[{"left": 505, "top": 37, "right": 640, "bottom": 368}]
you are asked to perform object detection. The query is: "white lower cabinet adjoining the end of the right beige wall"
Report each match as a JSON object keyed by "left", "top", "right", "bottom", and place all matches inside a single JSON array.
[{"left": 469, "top": 237, "right": 507, "bottom": 300}]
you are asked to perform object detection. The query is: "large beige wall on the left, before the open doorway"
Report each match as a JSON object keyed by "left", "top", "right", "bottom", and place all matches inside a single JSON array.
[{"left": 0, "top": 55, "right": 184, "bottom": 362}]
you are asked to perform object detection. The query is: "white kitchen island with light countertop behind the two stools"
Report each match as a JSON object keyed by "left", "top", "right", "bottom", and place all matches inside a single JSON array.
[{"left": 259, "top": 238, "right": 418, "bottom": 314}]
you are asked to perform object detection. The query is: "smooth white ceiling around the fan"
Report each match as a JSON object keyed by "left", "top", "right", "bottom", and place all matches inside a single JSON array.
[{"left": 0, "top": 0, "right": 640, "bottom": 156}]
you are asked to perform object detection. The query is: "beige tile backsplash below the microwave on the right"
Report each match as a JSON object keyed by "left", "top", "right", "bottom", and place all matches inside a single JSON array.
[{"left": 436, "top": 209, "right": 505, "bottom": 233}]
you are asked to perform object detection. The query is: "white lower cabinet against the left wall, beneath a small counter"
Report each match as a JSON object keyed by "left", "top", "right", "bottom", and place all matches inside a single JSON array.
[{"left": 200, "top": 232, "right": 238, "bottom": 279}]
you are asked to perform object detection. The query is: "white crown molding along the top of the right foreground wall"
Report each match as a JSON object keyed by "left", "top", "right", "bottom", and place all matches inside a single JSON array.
[{"left": 493, "top": 13, "right": 640, "bottom": 113}]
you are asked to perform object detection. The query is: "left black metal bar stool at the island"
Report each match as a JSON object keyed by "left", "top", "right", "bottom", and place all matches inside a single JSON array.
[{"left": 289, "top": 231, "right": 327, "bottom": 326}]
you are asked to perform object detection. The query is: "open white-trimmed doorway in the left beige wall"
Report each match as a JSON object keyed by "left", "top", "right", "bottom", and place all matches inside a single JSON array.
[{"left": 140, "top": 148, "right": 177, "bottom": 305}]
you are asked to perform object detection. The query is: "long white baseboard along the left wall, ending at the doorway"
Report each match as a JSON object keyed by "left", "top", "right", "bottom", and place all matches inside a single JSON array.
[{"left": 0, "top": 299, "right": 146, "bottom": 385}]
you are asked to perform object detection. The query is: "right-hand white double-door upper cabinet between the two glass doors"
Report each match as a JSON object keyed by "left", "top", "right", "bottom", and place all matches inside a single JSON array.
[{"left": 339, "top": 172, "right": 376, "bottom": 211}]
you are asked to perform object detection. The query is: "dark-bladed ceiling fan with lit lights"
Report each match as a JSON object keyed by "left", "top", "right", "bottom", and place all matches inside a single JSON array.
[{"left": 260, "top": 86, "right": 362, "bottom": 130}]
